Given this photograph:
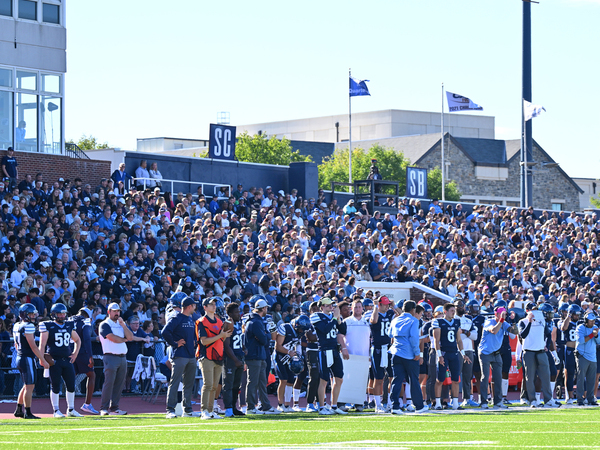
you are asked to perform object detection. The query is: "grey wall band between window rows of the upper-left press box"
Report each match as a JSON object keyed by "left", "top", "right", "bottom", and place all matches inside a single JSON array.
[{"left": 0, "top": 16, "right": 67, "bottom": 73}]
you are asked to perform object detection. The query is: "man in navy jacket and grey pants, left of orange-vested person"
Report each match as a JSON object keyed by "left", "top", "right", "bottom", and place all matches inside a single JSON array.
[{"left": 161, "top": 294, "right": 197, "bottom": 419}]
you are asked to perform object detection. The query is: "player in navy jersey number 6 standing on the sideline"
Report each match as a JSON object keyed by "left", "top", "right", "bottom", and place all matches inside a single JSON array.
[{"left": 431, "top": 303, "right": 471, "bottom": 410}]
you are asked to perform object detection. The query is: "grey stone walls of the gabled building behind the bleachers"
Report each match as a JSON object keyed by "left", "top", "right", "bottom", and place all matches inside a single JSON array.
[{"left": 415, "top": 136, "right": 580, "bottom": 211}]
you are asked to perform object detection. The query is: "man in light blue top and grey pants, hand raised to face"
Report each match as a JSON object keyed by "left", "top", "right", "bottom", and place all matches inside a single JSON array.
[{"left": 479, "top": 307, "right": 510, "bottom": 409}]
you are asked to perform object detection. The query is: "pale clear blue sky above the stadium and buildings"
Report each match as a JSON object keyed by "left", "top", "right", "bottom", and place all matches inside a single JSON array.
[{"left": 66, "top": 0, "right": 600, "bottom": 178}]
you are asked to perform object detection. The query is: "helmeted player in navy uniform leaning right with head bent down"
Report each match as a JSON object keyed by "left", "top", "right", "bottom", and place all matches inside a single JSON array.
[{"left": 273, "top": 316, "right": 311, "bottom": 412}]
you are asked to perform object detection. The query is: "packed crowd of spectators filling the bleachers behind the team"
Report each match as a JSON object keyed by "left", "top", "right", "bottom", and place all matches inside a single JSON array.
[{"left": 0, "top": 156, "right": 600, "bottom": 422}]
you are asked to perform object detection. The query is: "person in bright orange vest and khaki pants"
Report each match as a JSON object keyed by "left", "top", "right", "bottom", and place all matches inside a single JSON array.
[{"left": 196, "top": 297, "right": 232, "bottom": 419}]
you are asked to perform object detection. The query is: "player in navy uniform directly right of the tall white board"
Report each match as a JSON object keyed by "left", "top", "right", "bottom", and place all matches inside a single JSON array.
[{"left": 365, "top": 296, "right": 396, "bottom": 414}]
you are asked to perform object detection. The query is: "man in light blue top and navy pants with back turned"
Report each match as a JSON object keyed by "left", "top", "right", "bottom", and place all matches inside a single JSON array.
[{"left": 388, "top": 300, "right": 425, "bottom": 414}]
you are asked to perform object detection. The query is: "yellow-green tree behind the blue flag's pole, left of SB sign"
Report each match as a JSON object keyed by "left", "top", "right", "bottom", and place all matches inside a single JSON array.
[{"left": 319, "top": 144, "right": 409, "bottom": 195}]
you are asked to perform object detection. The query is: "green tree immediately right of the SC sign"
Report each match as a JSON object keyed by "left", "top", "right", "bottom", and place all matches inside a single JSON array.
[{"left": 235, "top": 132, "right": 312, "bottom": 166}]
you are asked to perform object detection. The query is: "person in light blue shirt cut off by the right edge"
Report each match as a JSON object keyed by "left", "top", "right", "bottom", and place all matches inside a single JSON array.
[{"left": 575, "top": 311, "right": 600, "bottom": 406}]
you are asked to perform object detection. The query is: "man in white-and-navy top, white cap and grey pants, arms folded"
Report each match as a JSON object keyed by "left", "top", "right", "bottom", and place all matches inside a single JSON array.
[{"left": 98, "top": 303, "right": 133, "bottom": 416}]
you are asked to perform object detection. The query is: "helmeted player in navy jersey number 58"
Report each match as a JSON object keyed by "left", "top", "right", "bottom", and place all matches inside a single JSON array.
[{"left": 39, "top": 303, "right": 83, "bottom": 418}]
